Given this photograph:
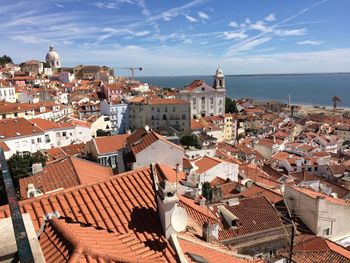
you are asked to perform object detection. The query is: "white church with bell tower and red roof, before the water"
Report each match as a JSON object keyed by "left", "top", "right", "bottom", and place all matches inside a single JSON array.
[{"left": 177, "top": 69, "right": 226, "bottom": 119}]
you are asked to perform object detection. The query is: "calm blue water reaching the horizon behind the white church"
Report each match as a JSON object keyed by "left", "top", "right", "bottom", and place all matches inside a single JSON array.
[{"left": 137, "top": 72, "right": 350, "bottom": 108}]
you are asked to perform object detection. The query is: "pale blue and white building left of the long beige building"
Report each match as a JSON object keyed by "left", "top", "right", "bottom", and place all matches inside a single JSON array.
[{"left": 100, "top": 100, "right": 129, "bottom": 134}]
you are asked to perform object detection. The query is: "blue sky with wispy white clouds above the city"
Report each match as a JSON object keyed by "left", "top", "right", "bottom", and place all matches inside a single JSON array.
[{"left": 0, "top": 0, "right": 350, "bottom": 76}]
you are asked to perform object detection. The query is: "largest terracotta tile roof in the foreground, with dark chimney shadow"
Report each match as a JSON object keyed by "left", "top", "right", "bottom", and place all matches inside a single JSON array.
[{"left": 0, "top": 168, "right": 176, "bottom": 262}]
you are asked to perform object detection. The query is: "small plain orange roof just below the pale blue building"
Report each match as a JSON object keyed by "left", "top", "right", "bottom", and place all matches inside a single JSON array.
[{"left": 93, "top": 134, "right": 130, "bottom": 154}]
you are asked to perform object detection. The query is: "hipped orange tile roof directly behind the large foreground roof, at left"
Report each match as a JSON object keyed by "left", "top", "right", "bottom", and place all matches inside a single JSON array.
[{"left": 19, "top": 157, "right": 113, "bottom": 199}]
